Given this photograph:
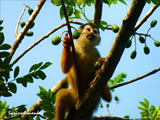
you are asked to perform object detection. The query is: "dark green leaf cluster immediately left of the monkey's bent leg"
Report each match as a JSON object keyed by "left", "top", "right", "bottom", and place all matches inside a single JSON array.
[{"left": 37, "top": 86, "right": 56, "bottom": 119}]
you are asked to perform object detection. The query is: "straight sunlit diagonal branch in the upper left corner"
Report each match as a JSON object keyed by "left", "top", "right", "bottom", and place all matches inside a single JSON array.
[{"left": 9, "top": 0, "right": 46, "bottom": 61}]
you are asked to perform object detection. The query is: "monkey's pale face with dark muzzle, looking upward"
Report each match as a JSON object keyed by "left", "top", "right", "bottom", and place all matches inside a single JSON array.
[{"left": 77, "top": 25, "right": 100, "bottom": 46}]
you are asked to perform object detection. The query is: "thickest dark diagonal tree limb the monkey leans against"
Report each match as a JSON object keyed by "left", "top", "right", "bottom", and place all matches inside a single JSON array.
[{"left": 67, "top": 0, "right": 146, "bottom": 120}]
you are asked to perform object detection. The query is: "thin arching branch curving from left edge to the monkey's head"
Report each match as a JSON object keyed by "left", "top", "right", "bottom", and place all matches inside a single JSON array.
[{"left": 11, "top": 21, "right": 82, "bottom": 66}]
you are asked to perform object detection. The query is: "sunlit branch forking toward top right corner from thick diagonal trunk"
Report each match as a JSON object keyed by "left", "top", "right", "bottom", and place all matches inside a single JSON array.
[{"left": 134, "top": 5, "right": 159, "bottom": 31}]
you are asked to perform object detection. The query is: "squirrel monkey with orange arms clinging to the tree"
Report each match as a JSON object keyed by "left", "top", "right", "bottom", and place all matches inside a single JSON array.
[{"left": 56, "top": 23, "right": 112, "bottom": 120}]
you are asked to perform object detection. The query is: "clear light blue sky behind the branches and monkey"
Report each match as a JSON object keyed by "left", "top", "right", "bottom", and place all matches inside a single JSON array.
[{"left": 0, "top": 0, "right": 160, "bottom": 118}]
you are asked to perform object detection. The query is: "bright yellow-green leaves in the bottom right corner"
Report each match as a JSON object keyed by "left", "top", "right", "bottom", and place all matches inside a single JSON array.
[{"left": 138, "top": 98, "right": 160, "bottom": 120}]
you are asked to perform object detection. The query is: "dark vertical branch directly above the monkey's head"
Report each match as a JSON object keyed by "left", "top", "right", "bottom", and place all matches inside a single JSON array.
[{"left": 93, "top": 0, "right": 103, "bottom": 26}]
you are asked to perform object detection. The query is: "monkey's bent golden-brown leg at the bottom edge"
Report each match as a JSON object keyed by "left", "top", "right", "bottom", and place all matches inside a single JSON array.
[{"left": 56, "top": 89, "right": 77, "bottom": 120}]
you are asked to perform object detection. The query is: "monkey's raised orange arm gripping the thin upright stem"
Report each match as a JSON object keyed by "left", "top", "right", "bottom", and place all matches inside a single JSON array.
[{"left": 61, "top": 33, "right": 72, "bottom": 73}]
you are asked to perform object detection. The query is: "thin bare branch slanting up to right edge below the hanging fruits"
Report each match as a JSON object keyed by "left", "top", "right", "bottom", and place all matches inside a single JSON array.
[{"left": 110, "top": 68, "right": 160, "bottom": 90}]
